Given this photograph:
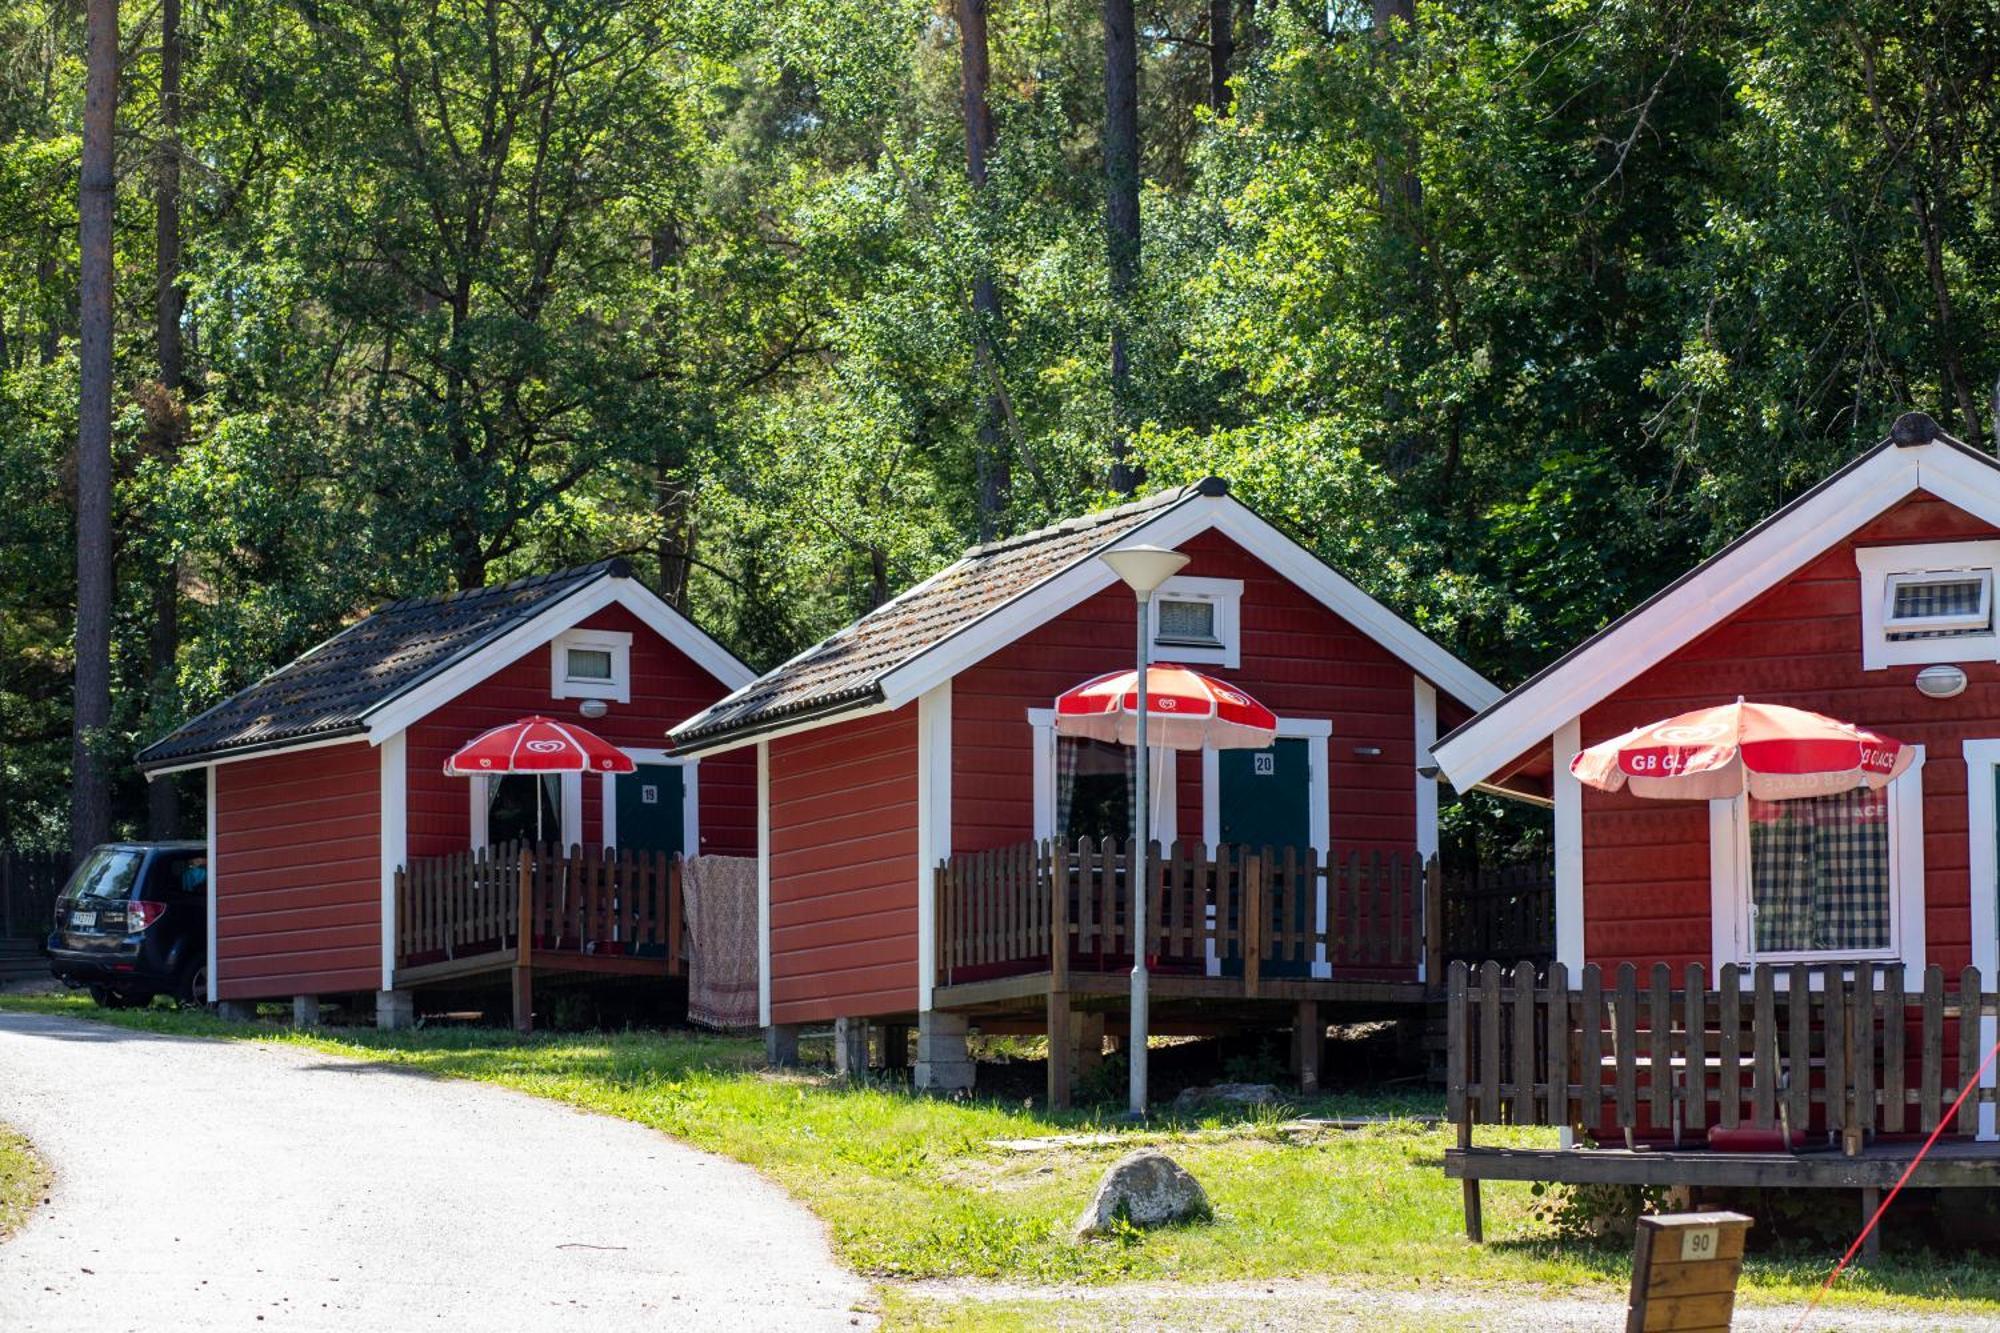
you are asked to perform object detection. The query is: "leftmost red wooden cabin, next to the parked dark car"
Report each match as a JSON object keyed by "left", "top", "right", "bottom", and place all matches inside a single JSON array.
[{"left": 138, "top": 560, "right": 756, "bottom": 1023}]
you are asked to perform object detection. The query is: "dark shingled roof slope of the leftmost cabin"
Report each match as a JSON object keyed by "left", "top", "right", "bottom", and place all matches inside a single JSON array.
[{"left": 138, "top": 560, "right": 630, "bottom": 769}]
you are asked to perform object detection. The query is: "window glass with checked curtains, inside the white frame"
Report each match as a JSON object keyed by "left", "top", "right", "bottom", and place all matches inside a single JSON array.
[{"left": 1750, "top": 789, "right": 1890, "bottom": 953}]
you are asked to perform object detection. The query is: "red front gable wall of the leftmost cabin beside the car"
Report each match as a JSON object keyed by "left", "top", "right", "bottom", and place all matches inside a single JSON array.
[{"left": 406, "top": 606, "right": 756, "bottom": 857}]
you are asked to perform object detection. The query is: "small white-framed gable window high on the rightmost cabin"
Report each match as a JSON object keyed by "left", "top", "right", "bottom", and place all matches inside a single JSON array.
[{"left": 1854, "top": 542, "right": 2000, "bottom": 671}]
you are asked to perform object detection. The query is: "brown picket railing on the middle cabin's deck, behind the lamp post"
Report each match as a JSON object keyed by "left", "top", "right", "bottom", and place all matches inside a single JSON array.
[{"left": 936, "top": 839, "right": 1438, "bottom": 995}]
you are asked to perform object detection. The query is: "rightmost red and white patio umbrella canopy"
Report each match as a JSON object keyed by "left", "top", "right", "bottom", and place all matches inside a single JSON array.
[{"left": 1570, "top": 699, "right": 1916, "bottom": 801}]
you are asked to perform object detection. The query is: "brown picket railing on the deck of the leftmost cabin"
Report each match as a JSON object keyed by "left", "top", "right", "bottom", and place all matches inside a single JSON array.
[{"left": 396, "top": 843, "right": 684, "bottom": 975}]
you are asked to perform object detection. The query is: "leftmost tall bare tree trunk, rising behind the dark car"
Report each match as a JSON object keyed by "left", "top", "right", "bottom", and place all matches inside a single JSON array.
[{"left": 146, "top": 0, "right": 186, "bottom": 839}]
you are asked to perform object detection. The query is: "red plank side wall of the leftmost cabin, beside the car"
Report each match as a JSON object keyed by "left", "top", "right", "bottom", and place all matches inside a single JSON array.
[{"left": 214, "top": 741, "right": 382, "bottom": 999}]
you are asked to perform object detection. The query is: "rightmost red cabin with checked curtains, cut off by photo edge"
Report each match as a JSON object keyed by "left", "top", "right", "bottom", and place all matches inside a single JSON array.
[{"left": 1436, "top": 414, "right": 2000, "bottom": 1185}]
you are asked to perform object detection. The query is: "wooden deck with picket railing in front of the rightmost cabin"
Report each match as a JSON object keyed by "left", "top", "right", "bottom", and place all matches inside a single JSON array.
[{"left": 1444, "top": 963, "right": 2000, "bottom": 1241}]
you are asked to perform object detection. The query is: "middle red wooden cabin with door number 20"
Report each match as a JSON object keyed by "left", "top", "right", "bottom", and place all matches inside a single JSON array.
[{"left": 674, "top": 478, "right": 1498, "bottom": 1085}]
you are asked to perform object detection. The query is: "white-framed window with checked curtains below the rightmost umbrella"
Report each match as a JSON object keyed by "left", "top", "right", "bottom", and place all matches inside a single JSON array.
[{"left": 1710, "top": 753, "right": 1924, "bottom": 969}]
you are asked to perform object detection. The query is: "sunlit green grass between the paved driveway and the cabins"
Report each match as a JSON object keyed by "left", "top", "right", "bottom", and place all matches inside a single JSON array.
[{"left": 0, "top": 997, "right": 2000, "bottom": 1323}]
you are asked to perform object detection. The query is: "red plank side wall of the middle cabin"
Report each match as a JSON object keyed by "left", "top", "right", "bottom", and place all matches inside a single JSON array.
[{"left": 770, "top": 705, "right": 916, "bottom": 1023}]
